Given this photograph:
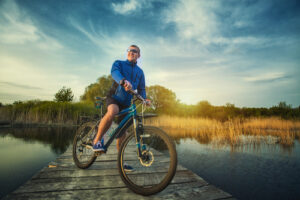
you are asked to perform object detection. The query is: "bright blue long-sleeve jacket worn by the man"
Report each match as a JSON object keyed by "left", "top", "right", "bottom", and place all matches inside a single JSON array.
[{"left": 111, "top": 60, "right": 146, "bottom": 106}]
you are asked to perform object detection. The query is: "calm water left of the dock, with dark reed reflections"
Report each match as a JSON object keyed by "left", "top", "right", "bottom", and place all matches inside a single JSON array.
[{"left": 0, "top": 127, "right": 76, "bottom": 199}]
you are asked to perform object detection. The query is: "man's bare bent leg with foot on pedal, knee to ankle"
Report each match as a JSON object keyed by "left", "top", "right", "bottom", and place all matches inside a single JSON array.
[{"left": 93, "top": 104, "right": 119, "bottom": 145}]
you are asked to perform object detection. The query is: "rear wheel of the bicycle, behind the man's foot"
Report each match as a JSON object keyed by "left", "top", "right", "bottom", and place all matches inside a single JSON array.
[{"left": 73, "top": 122, "right": 97, "bottom": 169}]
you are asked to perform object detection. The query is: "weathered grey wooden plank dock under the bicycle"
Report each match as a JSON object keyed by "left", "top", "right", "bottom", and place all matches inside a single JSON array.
[{"left": 4, "top": 145, "right": 234, "bottom": 200}]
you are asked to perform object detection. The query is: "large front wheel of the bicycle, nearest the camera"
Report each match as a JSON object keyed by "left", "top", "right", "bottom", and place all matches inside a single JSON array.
[{"left": 118, "top": 126, "right": 177, "bottom": 196}]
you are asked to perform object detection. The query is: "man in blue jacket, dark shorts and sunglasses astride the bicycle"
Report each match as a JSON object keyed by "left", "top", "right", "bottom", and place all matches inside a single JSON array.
[{"left": 93, "top": 45, "right": 150, "bottom": 162}]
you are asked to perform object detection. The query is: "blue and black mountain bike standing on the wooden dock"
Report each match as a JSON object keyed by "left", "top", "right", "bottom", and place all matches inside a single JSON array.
[{"left": 73, "top": 90, "right": 177, "bottom": 196}]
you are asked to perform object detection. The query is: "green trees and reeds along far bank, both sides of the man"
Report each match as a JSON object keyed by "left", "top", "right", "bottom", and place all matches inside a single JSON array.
[{"left": 0, "top": 76, "right": 300, "bottom": 124}]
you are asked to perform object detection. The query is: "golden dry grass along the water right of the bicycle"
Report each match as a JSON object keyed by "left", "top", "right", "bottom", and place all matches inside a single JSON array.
[{"left": 145, "top": 115, "right": 300, "bottom": 146}]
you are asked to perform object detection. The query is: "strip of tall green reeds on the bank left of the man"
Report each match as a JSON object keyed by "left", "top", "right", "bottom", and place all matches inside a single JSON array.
[{"left": 0, "top": 100, "right": 97, "bottom": 125}]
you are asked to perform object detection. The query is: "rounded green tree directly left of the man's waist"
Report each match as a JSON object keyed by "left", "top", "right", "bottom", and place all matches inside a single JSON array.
[{"left": 80, "top": 75, "right": 114, "bottom": 102}]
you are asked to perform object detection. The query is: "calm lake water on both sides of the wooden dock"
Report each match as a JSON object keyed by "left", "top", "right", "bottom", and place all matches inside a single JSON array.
[{"left": 0, "top": 127, "right": 300, "bottom": 199}]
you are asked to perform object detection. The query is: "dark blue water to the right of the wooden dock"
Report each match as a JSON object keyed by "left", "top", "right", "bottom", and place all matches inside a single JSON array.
[{"left": 177, "top": 139, "right": 300, "bottom": 199}]
